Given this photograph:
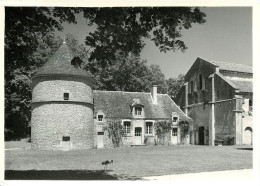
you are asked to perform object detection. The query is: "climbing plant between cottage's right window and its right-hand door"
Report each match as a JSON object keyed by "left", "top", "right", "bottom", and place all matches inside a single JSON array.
[{"left": 154, "top": 120, "right": 172, "bottom": 145}]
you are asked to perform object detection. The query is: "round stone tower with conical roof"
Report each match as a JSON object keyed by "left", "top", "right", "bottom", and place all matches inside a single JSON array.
[{"left": 31, "top": 42, "right": 94, "bottom": 150}]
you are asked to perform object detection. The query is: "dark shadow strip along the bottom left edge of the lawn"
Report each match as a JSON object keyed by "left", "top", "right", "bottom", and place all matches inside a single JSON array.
[{"left": 5, "top": 170, "right": 140, "bottom": 180}]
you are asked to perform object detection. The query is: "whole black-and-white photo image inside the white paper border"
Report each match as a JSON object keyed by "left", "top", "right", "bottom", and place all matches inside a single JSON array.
[{"left": 3, "top": 6, "right": 254, "bottom": 183}]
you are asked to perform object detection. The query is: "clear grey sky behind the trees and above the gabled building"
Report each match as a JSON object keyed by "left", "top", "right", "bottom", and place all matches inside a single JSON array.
[{"left": 54, "top": 7, "right": 252, "bottom": 79}]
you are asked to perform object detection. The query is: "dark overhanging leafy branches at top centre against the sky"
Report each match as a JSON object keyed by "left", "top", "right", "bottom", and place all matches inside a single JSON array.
[{"left": 82, "top": 7, "right": 206, "bottom": 66}]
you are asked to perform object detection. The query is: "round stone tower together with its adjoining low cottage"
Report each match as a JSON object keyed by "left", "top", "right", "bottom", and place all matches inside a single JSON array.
[{"left": 31, "top": 42, "right": 192, "bottom": 150}]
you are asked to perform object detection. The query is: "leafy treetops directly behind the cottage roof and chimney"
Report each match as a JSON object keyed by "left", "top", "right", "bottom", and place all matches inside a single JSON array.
[{"left": 87, "top": 53, "right": 167, "bottom": 93}]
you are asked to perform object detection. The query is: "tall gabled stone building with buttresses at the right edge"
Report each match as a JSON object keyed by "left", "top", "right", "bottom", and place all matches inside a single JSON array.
[{"left": 175, "top": 58, "right": 253, "bottom": 145}]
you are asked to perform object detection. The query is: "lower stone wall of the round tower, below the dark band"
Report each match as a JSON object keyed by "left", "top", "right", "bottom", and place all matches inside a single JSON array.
[{"left": 31, "top": 103, "right": 94, "bottom": 150}]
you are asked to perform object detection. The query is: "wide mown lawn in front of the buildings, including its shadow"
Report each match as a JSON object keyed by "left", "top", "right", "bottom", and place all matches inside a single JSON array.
[{"left": 5, "top": 146, "right": 253, "bottom": 180}]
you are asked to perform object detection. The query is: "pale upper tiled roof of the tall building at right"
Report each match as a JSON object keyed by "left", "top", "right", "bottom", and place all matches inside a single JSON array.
[{"left": 208, "top": 61, "right": 253, "bottom": 73}]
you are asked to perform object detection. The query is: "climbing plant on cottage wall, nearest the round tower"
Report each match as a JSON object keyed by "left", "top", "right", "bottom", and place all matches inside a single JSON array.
[{"left": 103, "top": 120, "right": 124, "bottom": 148}]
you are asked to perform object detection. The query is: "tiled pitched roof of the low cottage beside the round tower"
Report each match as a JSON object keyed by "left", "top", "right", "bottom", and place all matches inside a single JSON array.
[{"left": 93, "top": 90, "right": 191, "bottom": 122}]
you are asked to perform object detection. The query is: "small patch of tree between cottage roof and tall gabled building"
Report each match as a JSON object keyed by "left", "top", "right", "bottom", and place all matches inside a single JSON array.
[{"left": 166, "top": 74, "right": 184, "bottom": 100}]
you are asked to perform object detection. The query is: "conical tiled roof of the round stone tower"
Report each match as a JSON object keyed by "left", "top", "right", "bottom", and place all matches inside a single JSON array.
[{"left": 34, "top": 42, "right": 90, "bottom": 77}]
